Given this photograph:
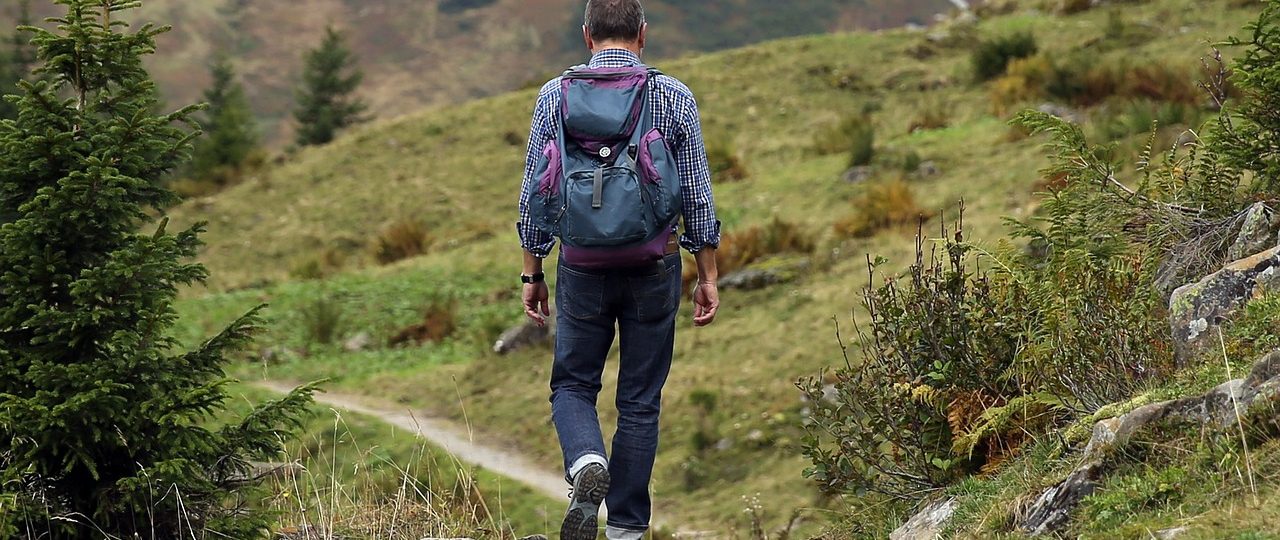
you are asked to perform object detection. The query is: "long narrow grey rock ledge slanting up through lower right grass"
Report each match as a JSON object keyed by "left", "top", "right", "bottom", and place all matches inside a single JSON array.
[{"left": 1019, "top": 351, "right": 1280, "bottom": 536}]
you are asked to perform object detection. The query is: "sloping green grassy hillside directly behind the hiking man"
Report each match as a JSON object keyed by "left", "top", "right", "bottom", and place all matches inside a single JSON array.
[{"left": 173, "top": 0, "right": 1252, "bottom": 531}]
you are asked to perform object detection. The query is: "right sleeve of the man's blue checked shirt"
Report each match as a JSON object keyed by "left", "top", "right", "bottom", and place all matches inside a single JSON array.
[{"left": 676, "top": 99, "right": 721, "bottom": 253}]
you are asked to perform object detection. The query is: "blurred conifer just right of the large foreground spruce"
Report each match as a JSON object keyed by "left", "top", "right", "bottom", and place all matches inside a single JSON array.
[{"left": 191, "top": 56, "right": 259, "bottom": 184}]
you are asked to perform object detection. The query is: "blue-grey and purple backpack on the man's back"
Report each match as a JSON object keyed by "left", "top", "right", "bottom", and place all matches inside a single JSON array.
[{"left": 527, "top": 65, "right": 681, "bottom": 269}]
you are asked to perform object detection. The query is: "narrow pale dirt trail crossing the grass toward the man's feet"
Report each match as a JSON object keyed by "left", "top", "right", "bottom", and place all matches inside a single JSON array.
[{"left": 253, "top": 381, "right": 568, "bottom": 502}]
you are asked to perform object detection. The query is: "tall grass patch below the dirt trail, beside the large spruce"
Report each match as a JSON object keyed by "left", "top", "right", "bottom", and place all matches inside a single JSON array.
[{"left": 221, "top": 385, "right": 563, "bottom": 539}]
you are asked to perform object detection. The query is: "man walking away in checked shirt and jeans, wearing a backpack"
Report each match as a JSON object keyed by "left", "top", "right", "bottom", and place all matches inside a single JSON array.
[{"left": 517, "top": 0, "right": 719, "bottom": 540}]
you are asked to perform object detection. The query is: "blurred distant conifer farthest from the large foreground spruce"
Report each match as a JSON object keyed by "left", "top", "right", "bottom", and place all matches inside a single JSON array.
[{"left": 293, "top": 27, "right": 369, "bottom": 146}]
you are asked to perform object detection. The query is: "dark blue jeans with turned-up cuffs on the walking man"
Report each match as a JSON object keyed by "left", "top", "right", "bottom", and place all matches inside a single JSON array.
[{"left": 550, "top": 253, "right": 681, "bottom": 531}]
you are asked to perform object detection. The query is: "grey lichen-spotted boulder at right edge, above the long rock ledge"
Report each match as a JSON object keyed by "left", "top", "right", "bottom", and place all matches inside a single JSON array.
[{"left": 1169, "top": 247, "right": 1280, "bottom": 363}]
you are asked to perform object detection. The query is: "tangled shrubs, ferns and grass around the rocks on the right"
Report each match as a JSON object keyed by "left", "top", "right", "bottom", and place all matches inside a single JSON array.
[{"left": 800, "top": 1, "right": 1280, "bottom": 537}]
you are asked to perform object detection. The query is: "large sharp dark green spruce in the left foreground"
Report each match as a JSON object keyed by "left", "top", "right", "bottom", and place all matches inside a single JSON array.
[{"left": 0, "top": 0, "right": 311, "bottom": 539}]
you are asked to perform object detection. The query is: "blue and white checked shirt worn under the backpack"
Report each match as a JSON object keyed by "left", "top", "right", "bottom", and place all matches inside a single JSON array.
[{"left": 516, "top": 49, "right": 719, "bottom": 257}]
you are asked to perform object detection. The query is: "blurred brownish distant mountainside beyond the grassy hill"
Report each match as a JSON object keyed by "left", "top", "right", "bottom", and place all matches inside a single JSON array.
[{"left": 0, "top": 0, "right": 951, "bottom": 142}]
